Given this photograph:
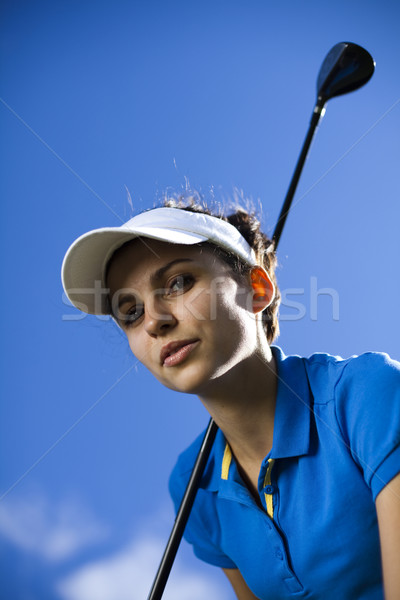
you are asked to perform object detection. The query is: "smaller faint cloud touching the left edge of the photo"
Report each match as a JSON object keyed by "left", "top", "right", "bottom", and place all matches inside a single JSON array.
[{"left": 0, "top": 494, "right": 106, "bottom": 561}]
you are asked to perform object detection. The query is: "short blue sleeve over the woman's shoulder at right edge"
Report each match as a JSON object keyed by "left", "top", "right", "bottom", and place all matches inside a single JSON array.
[{"left": 335, "top": 352, "right": 400, "bottom": 500}]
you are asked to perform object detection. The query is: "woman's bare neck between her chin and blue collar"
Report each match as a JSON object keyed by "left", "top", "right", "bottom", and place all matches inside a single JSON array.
[{"left": 200, "top": 347, "right": 277, "bottom": 469}]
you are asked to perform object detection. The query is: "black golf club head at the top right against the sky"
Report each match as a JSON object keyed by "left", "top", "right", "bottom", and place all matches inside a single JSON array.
[{"left": 317, "top": 42, "right": 375, "bottom": 105}]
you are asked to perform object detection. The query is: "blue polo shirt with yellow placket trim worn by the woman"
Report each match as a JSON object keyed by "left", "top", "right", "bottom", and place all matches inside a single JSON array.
[{"left": 170, "top": 347, "right": 400, "bottom": 600}]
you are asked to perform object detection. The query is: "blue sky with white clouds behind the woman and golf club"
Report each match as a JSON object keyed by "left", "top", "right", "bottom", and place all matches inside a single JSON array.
[{"left": 0, "top": 0, "right": 400, "bottom": 600}]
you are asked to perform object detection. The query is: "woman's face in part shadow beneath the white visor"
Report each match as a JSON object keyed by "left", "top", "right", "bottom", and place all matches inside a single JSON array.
[{"left": 107, "top": 239, "right": 257, "bottom": 395}]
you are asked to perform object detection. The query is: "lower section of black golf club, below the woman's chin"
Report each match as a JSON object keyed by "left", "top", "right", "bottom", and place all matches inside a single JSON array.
[{"left": 147, "top": 419, "right": 218, "bottom": 600}]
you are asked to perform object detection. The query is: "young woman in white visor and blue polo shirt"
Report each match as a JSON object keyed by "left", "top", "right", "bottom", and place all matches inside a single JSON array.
[{"left": 63, "top": 202, "right": 400, "bottom": 600}]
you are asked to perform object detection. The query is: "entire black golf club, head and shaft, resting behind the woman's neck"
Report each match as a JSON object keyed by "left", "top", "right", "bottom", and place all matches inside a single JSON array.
[{"left": 148, "top": 42, "right": 375, "bottom": 600}]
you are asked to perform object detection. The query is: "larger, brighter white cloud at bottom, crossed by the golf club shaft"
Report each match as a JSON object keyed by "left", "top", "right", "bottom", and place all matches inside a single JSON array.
[{"left": 58, "top": 536, "right": 232, "bottom": 600}]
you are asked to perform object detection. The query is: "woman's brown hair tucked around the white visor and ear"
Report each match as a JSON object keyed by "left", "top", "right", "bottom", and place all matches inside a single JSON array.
[{"left": 163, "top": 194, "right": 281, "bottom": 344}]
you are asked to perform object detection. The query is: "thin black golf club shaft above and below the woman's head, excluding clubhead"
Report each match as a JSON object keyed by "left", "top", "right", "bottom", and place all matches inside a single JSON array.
[{"left": 147, "top": 102, "right": 323, "bottom": 600}]
